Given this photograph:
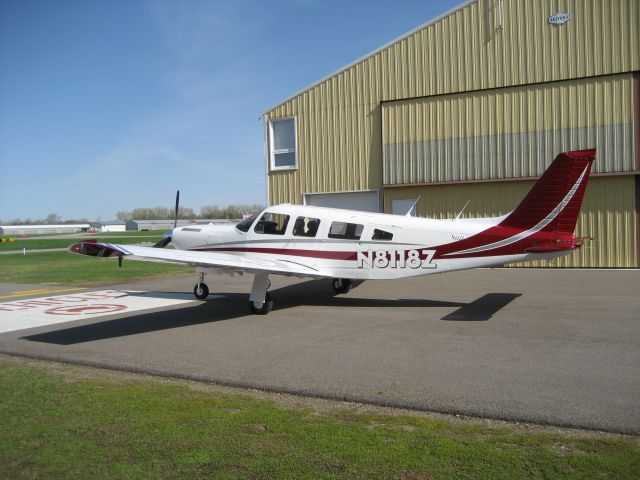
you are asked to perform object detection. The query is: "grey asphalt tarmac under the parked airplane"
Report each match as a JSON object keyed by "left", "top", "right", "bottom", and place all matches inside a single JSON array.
[{"left": 0, "top": 269, "right": 640, "bottom": 434}]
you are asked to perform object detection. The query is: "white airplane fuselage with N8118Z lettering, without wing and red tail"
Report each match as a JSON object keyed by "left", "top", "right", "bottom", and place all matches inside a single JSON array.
[{"left": 172, "top": 205, "right": 566, "bottom": 280}]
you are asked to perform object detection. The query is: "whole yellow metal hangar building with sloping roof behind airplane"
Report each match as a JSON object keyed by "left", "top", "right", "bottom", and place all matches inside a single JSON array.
[{"left": 264, "top": 0, "right": 640, "bottom": 268}]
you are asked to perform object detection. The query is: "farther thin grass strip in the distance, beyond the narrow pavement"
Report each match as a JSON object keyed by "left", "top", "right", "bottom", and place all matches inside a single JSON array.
[{"left": 0, "top": 230, "right": 165, "bottom": 252}]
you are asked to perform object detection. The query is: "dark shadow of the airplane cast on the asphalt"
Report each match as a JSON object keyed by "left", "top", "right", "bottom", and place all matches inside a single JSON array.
[{"left": 21, "top": 280, "right": 521, "bottom": 345}]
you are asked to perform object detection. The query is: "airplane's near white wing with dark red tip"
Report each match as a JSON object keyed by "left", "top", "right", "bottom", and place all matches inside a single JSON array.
[{"left": 69, "top": 242, "right": 326, "bottom": 277}]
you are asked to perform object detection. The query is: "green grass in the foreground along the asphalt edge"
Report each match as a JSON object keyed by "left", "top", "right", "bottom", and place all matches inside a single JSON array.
[{"left": 0, "top": 357, "right": 640, "bottom": 479}]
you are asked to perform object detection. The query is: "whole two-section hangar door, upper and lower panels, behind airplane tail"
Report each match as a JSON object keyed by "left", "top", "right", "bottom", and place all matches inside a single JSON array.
[{"left": 382, "top": 74, "right": 640, "bottom": 267}]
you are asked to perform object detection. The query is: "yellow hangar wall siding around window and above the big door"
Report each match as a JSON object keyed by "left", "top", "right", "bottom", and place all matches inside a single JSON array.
[{"left": 265, "top": 0, "right": 640, "bottom": 203}]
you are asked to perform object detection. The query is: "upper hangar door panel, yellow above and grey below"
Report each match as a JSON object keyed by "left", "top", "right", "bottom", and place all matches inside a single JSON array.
[{"left": 382, "top": 74, "right": 635, "bottom": 185}]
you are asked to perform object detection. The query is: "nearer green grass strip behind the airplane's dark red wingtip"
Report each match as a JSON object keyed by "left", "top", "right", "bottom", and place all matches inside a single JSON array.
[{"left": 0, "top": 252, "right": 193, "bottom": 285}]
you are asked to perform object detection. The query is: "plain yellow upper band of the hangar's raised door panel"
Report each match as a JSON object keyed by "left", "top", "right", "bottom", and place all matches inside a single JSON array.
[{"left": 383, "top": 73, "right": 633, "bottom": 143}]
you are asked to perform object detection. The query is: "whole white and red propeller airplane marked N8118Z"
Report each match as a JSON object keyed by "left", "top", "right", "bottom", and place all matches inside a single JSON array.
[{"left": 69, "top": 149, "right": 596, "bottom": 314}]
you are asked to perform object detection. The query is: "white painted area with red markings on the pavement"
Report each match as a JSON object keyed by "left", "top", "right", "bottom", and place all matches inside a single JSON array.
[{"left": 0, "top": 290, "right": 218, "bottom": 333}]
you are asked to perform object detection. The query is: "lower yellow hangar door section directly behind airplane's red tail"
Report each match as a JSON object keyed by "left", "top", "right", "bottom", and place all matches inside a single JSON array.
[{"left": 384, "top": 176, "right": 638, "bottom": 268}]
